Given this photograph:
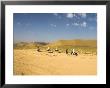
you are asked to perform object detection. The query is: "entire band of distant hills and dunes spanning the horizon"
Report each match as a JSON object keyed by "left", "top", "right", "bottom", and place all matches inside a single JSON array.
[{"left": 14, "top": 40, "right": 97, "bottom": 49}]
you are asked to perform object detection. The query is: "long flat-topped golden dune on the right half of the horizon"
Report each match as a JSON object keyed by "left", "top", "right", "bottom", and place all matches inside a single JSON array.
[{"left": 47, "top": 40, "right": 97, "bottom": 47}]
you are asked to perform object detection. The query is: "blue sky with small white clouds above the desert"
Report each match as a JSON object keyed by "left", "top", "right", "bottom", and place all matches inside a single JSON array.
[{"left": 13, "top": 13, "right": 97, "bottom": 42}]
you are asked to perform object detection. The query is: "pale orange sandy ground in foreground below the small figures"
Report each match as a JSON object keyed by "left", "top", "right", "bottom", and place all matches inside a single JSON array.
[{"left": 14, "top": 49, "right": 97, "bottom": 75}]
